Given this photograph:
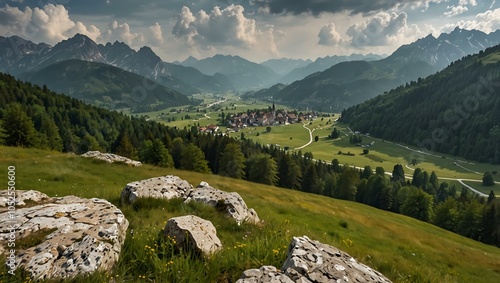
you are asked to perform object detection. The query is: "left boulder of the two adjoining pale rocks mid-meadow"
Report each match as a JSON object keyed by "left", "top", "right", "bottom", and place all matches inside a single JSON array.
[{"left": 121, "top": 175, "right": 193, "bottom": 203}]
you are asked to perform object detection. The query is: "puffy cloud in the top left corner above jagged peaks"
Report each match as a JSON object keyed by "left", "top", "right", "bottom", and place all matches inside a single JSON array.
[{"left": 0, "top": 4, "right": 100, "bottom": 44}]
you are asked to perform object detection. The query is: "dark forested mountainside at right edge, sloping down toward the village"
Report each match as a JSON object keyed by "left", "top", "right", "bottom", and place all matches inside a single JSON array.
[{"left": 341, "top": 45, "right": 500, "bottom": 164}]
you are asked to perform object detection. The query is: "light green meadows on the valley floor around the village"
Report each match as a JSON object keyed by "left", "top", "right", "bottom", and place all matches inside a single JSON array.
[{"left": 131, "top": 94, "right": 498, "bottom": 190}]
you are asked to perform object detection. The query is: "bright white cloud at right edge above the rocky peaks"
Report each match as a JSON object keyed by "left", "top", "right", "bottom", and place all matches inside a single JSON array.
[{"left": 441, "top": 8, "right": 500, "bottom": 32}]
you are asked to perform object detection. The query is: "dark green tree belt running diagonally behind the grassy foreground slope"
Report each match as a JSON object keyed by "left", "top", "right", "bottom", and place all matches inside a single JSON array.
[{"left": 0, "top": 71, "right": 500, "bottom": 246}]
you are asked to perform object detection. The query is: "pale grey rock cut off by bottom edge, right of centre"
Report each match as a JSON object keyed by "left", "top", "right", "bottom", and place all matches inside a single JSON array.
[{"left": 237, "top": 236, "right": 391, "bottom": 283}]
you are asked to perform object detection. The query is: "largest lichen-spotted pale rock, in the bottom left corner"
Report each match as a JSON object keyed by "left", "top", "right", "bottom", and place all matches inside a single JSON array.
[{"left": 0, "top": 191, "right": 128, "bottom": 280}]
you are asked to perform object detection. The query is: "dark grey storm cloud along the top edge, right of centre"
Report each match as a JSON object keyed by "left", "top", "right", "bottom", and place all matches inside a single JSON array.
[{"left": 253, "top": 0, "right": 433, "bottom": 16}]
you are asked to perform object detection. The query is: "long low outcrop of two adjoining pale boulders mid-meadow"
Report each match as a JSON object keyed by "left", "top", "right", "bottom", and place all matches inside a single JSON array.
[{"left": 121, "top": 178, "right": 260, "bottom": 224}]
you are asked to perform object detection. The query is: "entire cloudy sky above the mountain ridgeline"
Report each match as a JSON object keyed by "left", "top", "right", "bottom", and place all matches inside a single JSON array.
[{"left": 0, "top": 0, "right": 500, "bottom": 62}]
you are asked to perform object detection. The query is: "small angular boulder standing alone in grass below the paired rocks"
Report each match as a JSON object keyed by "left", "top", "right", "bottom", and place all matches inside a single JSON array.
[{"left": 163, "top": 215, "right": 222, "bottom": 255}]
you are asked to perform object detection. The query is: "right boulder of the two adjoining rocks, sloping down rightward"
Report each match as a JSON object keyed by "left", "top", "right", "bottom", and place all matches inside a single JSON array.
[{"left": 185, "top": 182, "right": 260, "bottom": 224}]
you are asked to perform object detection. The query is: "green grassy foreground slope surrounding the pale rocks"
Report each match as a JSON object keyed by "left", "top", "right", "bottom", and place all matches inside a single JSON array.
[{"left": 0, "top": 147, "right": 500, "bottom": 282}]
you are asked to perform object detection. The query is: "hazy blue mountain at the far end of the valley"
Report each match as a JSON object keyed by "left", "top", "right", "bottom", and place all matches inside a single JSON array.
[{"left": 183, "top": 55, "right": 279, "bottom": 90}]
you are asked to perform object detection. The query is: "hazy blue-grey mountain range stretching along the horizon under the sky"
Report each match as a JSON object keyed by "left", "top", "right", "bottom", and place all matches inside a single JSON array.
[{"left": 0, "top": 28, "right": 500, "bottom": 111}]
